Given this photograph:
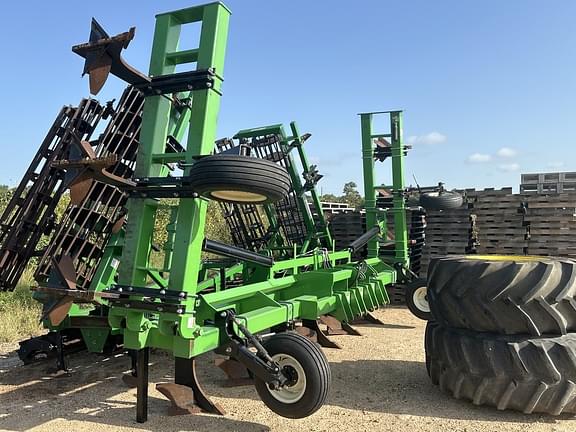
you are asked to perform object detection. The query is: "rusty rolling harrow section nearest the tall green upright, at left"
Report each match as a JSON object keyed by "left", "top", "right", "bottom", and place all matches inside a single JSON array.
[{"left": 35, "top": 87, "right": 144, "bottom": 290}]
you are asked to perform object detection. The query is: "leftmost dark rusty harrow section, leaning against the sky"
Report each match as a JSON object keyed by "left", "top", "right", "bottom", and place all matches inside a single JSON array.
[{"left": 0, "top": 99, "right": 108, "bottom": 291}]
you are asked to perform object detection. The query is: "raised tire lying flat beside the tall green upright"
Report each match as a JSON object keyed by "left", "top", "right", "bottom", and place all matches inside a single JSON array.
[{"left": 189, "top": 155, "right": 292, "bottom": 204}]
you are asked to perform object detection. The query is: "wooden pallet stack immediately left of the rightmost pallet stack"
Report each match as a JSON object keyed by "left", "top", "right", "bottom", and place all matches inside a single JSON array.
[{"left": 470, "top": 188, "right": 528, "bottom": 255}]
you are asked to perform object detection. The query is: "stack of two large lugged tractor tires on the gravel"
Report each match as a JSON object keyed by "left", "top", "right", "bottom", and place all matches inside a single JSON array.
[{"left": 425, "top": 255, "right": 576, "bottom": 415}]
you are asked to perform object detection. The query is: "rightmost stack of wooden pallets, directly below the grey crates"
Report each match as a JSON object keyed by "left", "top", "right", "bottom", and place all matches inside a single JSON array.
[{"left": 523, "top": 193, "right": 576, "bottom": 257}]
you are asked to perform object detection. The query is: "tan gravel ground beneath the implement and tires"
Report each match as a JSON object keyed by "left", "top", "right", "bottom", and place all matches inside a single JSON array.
[{"left": 0, "top": 308, "right": 576, "bottom": 432}]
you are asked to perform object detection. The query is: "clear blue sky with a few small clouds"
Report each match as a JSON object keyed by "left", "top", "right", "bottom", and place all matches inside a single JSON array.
[{"left": 0, "top": 0, "right": 576, "bottom": 193}]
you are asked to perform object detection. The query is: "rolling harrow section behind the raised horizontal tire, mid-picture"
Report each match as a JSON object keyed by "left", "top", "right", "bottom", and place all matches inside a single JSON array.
[{"left": 216, "top": 135, "right": 308, "bottom": 251}]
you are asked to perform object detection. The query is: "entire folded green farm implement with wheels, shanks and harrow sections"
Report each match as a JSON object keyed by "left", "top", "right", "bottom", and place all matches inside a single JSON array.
[{"left": 0, "top": 3, "right": 450, "bottom": 422}]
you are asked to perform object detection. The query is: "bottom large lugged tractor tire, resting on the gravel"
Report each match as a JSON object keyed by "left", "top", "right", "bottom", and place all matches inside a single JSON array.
[{"left": 426, "top": 322, "right": 576, "bottom": 415}]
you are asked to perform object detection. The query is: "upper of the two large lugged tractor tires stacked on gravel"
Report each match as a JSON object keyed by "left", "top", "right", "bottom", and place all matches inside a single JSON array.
[{"left": 428, "top": 255, "right": 576, "bottom": 336}]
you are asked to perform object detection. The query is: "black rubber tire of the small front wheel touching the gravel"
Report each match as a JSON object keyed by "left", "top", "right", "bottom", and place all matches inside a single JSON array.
[{"left": 254, "top": 332, "right": 332, "bottom": 419}]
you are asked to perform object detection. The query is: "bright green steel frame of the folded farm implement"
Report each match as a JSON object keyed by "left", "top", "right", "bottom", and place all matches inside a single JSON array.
[{"left": 21, "top": 2, "right": 418, "bottom": 417}]
